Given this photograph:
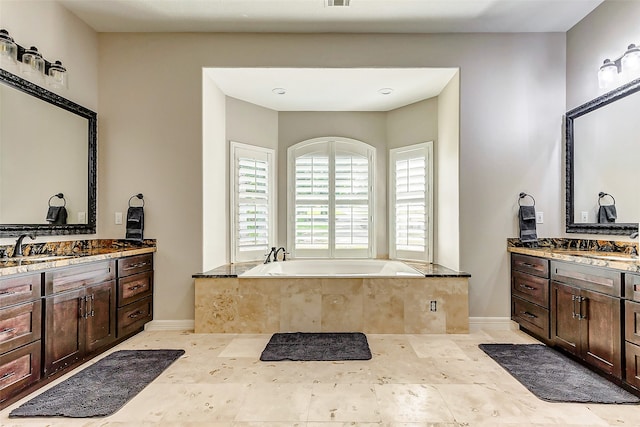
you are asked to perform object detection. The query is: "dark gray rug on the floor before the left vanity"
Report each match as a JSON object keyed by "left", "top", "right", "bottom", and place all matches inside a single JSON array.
[{"left": 9, "top": 350, "right": 184, "bottom": 418}]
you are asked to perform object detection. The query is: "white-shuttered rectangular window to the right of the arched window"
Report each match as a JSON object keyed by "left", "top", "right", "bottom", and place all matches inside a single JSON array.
[{"left": 389, "top": 142, "right": 433, "bottom": 262}]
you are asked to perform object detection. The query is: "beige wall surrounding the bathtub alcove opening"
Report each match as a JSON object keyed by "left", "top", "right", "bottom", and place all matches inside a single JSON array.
[{"left": 99, "top": 34, "right": 565, "bottom": 319}]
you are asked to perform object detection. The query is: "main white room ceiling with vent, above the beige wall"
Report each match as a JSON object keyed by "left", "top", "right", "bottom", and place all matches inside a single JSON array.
[{"left": 58, "top": 0, "right": 604, "bottom": 33}]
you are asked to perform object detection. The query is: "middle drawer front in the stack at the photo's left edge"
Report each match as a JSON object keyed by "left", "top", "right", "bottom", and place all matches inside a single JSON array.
[{"left": 0, "top": 300, "right": 42, "bottom": 353}]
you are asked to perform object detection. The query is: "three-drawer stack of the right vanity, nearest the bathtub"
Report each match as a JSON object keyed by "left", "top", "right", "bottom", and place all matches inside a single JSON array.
[{"left": 511, "top": 254, "right": 549, "bottom": 341}]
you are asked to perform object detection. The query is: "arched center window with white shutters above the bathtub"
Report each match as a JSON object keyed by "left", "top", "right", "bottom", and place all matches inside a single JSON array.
[{"left": 288, "top": 138, "right": 375, "bottom": 258}]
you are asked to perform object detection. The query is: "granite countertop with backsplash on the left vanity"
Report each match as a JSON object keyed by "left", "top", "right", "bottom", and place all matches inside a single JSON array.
[{"left": 0, "top": 239, "right": 156, "bottom": 277}]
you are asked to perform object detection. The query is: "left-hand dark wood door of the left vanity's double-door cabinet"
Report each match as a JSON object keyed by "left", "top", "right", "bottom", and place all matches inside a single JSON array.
[{"left": 44, "top": 289, "right": 86, "bottom": 375}]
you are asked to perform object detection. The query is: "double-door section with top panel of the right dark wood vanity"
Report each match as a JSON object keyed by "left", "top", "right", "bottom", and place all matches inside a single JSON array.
[{"left": 551, "top": 261, "right": 622, "bottom": 378}]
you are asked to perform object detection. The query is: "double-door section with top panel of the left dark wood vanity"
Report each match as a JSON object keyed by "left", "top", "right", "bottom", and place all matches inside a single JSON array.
[{"left": 43, "top": 261, "right": 116, "bottom": 376}]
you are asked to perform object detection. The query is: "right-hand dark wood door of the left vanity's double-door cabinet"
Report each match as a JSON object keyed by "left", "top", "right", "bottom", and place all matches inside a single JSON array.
[{"left": 85, "top": 280, "right": 116, "bottom": 353}]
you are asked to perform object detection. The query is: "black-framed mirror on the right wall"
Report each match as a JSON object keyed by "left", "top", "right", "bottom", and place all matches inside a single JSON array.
[{"left": 565, "top": 79, "right": 640, "bottom": 235}]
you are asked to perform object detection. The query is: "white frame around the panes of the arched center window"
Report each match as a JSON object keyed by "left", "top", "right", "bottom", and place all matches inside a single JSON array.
[{"left": 287, "top": 137, "right": 376, "bottom": 258}]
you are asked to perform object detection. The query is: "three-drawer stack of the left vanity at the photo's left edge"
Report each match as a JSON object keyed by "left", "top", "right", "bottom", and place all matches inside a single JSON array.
[{"left": 0, "top": 274, "right": 42, "bottom": 403}]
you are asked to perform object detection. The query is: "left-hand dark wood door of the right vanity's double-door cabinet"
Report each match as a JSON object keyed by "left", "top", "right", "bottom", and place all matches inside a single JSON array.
[{"left": 551, "top": 282, "right": 581, "bottom": 355}]
